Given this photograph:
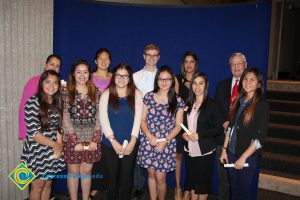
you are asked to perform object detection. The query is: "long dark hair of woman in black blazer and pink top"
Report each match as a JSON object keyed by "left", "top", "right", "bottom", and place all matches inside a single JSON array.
[{"left": 186, "top": 72, "right": 209, "bottom": 113}]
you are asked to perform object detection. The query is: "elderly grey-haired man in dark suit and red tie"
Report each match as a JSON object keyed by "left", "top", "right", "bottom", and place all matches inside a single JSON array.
[{"left": 215, "top": 53, "right": 247, "bottom": 200}]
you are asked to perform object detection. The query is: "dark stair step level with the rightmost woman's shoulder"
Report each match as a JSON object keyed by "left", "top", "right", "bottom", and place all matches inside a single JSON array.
[{"left": 267, "top": 99, "right": 300, "bottom": 113}]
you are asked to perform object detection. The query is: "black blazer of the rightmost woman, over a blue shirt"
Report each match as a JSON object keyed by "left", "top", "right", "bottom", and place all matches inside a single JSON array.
[{"left": 229, "top": 100, "right": 270, "bottom": 156}]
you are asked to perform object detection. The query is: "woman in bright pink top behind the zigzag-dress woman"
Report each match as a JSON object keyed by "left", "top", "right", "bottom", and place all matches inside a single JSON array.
[{"left": 19, "top": 54, "right": 61, "bottom": 140}]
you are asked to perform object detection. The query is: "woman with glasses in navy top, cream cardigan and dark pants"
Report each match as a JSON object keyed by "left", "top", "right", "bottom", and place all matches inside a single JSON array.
[{"left": 99, "top": 63, "right": 143, "bottom": 200}]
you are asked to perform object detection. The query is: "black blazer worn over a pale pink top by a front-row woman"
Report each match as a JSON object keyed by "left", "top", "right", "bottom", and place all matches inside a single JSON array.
[{"left": 181, "top": 99, "right": 224, "bottom": 154}]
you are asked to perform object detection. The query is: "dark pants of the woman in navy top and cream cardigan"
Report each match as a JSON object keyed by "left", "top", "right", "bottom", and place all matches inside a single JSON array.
[{"left": 102, "top": 144, "right": 138, "bottom": 200}]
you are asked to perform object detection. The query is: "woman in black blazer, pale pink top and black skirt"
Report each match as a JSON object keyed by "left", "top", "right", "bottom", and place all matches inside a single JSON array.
[{"left": 179, "top": 73, "right": 224, "bottom": 200}]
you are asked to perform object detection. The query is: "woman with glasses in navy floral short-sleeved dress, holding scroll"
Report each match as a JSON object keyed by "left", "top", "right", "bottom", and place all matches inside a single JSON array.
[{"left": 138, "top": 66, "right": 184, "bottom": 200}]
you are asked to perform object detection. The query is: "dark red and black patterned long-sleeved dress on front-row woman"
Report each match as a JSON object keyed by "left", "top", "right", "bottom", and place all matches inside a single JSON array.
[{"left": 63, "top": 88, "right": 101, "bottom": 164}]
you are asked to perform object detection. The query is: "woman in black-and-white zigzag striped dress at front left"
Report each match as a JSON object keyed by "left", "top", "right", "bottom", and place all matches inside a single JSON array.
[{"left": 21, "top": 70, "right": 65, "bottom": 200}]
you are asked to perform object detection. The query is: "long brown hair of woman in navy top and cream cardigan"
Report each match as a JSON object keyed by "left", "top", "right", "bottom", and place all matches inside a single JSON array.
[{"left": 108, "top": 63, "right": 136, "bottom": 114}]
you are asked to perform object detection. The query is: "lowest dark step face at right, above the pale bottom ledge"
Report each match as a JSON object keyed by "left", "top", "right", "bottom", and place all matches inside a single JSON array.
[{"left": 261, "top": 151, "right": 300, "bottom": 177}]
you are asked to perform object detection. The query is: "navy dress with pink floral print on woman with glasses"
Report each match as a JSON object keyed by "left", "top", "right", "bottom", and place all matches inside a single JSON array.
[{"left": 137, "top": 92, "right": 184, "bottom": 173}]
